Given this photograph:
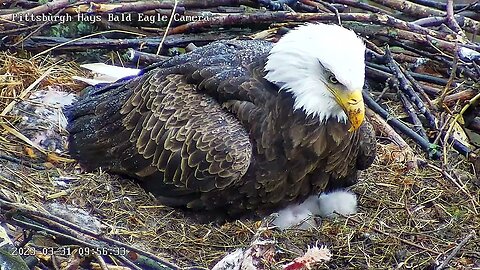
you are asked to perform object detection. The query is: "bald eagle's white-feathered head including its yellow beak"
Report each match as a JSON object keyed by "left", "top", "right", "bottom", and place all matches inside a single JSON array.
[{"left": 265, "top": 24, "right": 365, "bottom": 130}]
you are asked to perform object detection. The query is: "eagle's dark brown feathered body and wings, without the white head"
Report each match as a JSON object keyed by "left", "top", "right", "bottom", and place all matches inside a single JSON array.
[{"left": 69, "top": 41, "right": 375, "bottom": 215}]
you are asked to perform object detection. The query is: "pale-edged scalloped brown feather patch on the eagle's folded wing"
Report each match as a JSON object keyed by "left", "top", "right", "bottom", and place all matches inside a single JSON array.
[{"left": 120, "top": 72, "right": 252, "bottom": 192}]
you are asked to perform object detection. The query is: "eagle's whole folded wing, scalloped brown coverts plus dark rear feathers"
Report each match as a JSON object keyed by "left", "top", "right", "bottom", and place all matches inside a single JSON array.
[{"left": 70, "top": 46, "right": 262, "bottom": 200}]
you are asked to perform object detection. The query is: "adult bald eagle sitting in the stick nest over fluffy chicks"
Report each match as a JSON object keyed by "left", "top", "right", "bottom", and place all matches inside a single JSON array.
[{"left": 68, "top": 24, "right": 375, "bottom": 216}]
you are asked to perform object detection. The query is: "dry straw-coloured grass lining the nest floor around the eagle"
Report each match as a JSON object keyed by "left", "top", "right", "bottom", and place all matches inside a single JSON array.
[{"left": 0, "top": 54, "right": 480, "bottom": 269}]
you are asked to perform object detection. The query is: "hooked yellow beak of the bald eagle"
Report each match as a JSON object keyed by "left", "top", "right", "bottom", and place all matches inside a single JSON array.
[{"left": 334, "top": 89, "right": 365, "bottom": 132}]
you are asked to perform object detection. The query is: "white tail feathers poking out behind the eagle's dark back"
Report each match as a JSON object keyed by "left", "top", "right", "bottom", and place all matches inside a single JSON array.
[{"left": 73, "top": 63, "right": 141, "bottom": 85}]
